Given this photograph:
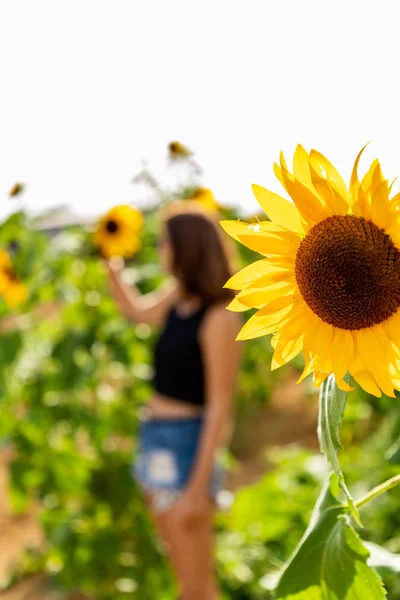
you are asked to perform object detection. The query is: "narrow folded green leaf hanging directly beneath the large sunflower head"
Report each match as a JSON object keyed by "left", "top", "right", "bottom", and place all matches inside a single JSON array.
[{"left": 318, "top": 375, "right": 361, "bottom": 526}]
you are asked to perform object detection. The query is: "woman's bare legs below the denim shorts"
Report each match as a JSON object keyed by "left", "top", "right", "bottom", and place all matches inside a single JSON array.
[{"left": 152, "top": 502, "right": 219, "bottom": 600}]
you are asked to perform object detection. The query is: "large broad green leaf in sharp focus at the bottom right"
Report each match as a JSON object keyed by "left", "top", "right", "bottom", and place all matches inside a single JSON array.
[{"left": 275, "top": 483, "right": 386, "bottom": 600}]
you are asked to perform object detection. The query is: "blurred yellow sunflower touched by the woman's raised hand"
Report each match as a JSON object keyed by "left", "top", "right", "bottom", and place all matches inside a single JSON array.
[{"left": 94, "top": 205, "right": 143, "bottom": 258}]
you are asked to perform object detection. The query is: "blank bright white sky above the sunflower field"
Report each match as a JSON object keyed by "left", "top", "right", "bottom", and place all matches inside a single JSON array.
[{"left": 0, "top": 0, "right": 400, "bottom": 220}]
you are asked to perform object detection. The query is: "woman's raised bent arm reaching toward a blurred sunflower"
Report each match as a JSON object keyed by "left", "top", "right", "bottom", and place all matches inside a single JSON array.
[{"left": 106, "top": 261, "right": 177, "bottom": 325}]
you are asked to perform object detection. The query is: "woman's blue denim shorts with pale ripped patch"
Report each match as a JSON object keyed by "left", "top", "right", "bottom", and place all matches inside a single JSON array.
[{"left": 132, "top": 417, "right": 224, "bottom": 512}]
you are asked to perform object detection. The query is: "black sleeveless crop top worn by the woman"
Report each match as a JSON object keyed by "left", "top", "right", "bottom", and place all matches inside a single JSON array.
[{"left": 154, "top": 306, "right": 207, "bottom": 406}]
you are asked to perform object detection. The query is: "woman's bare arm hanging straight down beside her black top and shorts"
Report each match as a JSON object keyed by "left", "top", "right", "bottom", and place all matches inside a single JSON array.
[{"left": 172, "top": 307, "right": 241, "bottom": 524}]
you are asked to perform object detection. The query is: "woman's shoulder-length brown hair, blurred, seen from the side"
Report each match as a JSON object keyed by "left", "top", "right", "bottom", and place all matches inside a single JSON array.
[{"left": 165, "top": 209, "right": 234, "bottom": 304}]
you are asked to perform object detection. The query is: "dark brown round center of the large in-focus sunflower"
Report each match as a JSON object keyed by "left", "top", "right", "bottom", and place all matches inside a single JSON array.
[{"left": 295, "top": 215, "right": 400, "bottom": 330}]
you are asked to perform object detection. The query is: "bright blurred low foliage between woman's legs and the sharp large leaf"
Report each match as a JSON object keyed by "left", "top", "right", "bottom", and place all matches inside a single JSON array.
[{"left": 217, "top": 448, "right": 325, "bottom": 599}]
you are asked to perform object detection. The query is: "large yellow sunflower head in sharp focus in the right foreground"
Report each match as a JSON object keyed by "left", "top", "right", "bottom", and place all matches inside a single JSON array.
[{"left": 221, "top": 145, "right": 400, "bottom": 396}]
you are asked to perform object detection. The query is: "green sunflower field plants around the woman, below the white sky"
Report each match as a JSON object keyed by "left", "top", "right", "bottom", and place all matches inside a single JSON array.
[{"left": 0, "top": 142, "right": 400, "bottom": 600}]
